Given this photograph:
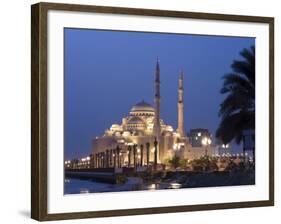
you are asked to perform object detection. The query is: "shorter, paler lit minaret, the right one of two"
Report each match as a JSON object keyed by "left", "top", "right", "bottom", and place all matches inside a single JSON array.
[{"left": 178, "top": 71, "right": 185, "bottom": 137}]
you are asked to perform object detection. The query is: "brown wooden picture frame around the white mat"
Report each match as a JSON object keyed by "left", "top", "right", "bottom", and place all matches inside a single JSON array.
[{"left": 31, "top": 3, "right": 274, "bottom": 221}]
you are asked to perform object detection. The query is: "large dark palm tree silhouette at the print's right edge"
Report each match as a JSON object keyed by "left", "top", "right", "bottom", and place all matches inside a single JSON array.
[{"left": 216, "top": 46, "right": 255, "bottom": 147}]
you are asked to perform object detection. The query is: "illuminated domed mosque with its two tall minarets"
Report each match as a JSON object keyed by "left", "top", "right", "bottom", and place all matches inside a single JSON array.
[{"left": 92, "top": 59, "right": 213, "bottom": 167}]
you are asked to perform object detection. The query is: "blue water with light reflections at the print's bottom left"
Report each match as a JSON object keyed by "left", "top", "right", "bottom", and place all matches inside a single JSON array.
[{"left": 64, "top": 177, "right": 181, "bottom": 194}]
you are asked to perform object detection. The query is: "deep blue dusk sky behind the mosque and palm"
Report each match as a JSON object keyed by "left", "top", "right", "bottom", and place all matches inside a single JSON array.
[{"left": 64, "top": 28, "right": 255, "bottom": 159}]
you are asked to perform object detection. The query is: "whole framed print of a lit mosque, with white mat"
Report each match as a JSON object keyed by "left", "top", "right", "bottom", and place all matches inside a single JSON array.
[{"left": 31, "top": 3, "right": 274, "bottom": 221}]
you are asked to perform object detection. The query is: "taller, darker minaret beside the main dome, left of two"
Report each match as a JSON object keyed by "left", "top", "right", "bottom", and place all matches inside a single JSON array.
[{"left": 153, "top": 58, "right": 161, "bottom": 138}]
